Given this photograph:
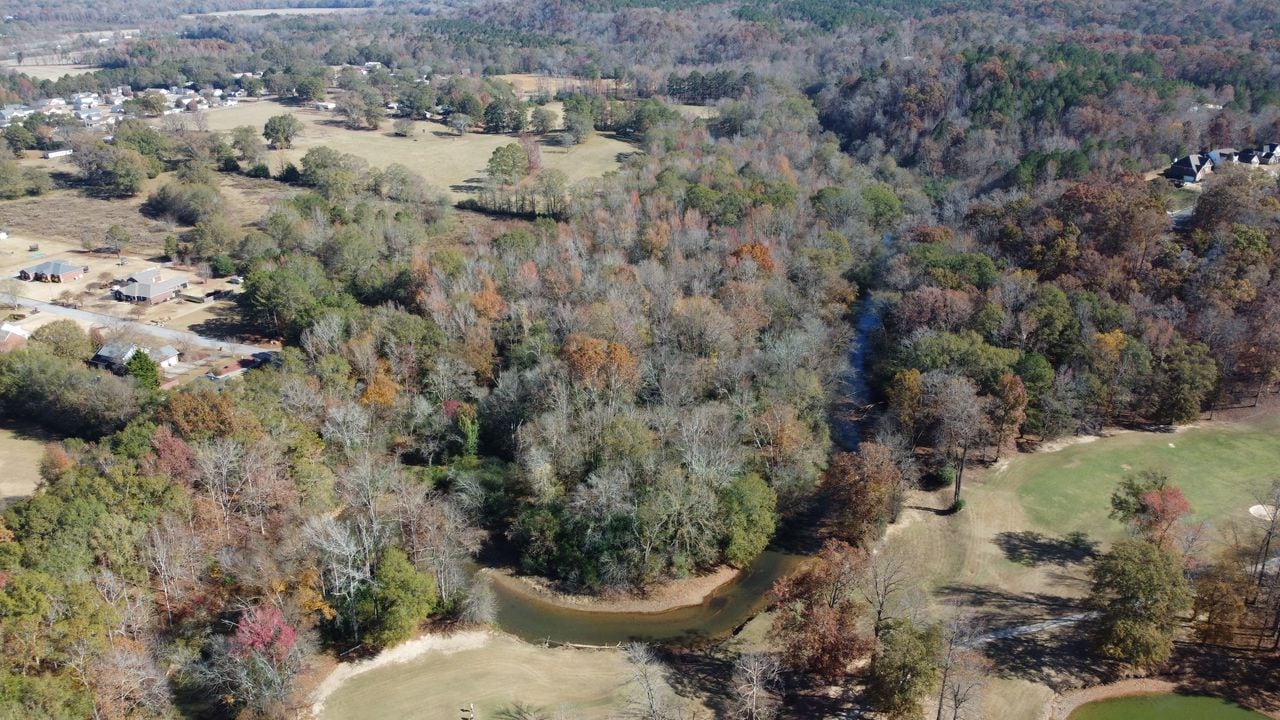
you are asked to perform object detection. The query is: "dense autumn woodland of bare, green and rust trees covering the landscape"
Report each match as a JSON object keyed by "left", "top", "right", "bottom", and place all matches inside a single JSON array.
[{"left": 0, "top": 0, "right": 1280, "bottom": 717}]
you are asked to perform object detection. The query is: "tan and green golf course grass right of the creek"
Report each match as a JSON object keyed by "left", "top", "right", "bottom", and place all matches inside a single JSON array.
[{"left": 884, "top": 415, "right": 1280, "bottom": 720}]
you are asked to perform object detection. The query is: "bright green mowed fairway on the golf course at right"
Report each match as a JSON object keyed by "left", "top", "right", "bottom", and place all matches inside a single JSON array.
[{"left": 1008, "top": 416, "right": 1280, "bottom": 538}]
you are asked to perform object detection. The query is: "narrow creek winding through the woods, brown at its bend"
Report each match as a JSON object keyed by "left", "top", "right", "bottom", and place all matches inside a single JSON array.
[{"left": 494, "top": 249, "right": 890, "bottom": 644}]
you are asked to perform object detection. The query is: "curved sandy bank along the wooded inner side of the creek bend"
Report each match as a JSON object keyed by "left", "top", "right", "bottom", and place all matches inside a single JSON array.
[{"left": 483, "top": 565, "right": 741, "bottom": 614}]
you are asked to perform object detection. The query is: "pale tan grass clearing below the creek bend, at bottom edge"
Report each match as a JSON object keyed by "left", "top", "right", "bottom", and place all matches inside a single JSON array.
[{"left": 319, "top": 635, "right": 686, "bottom": 720}]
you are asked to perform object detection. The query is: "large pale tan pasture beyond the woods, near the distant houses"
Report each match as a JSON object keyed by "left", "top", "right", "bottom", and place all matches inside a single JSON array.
[{"left": 209, "top": 101, "right": 636, "bottom": 200}]
